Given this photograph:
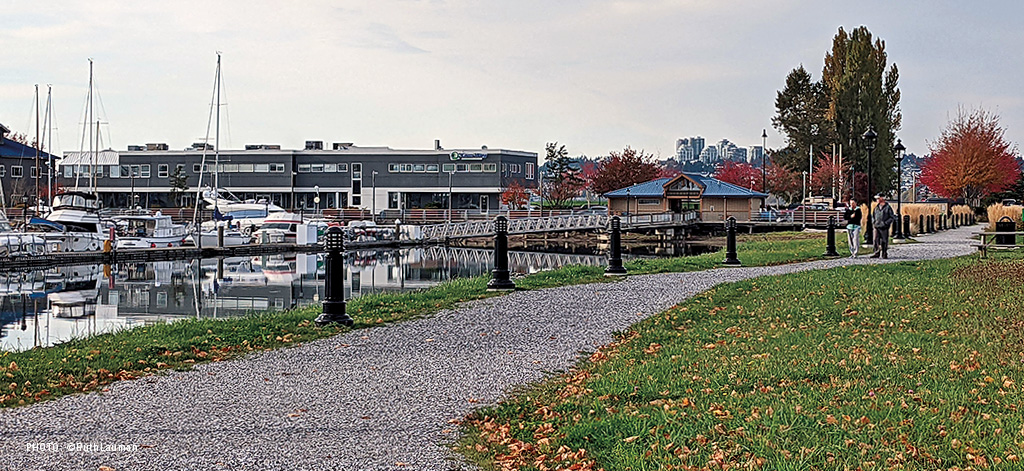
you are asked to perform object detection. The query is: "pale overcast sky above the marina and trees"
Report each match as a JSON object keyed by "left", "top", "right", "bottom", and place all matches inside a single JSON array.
[{"left": 0, "top": 0, "right": 1024, "bottom": 159}]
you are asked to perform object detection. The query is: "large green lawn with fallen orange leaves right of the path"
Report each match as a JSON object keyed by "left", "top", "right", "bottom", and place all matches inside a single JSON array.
[{"left": 457, "top": 254, "right": 1024, "bottom": 470}]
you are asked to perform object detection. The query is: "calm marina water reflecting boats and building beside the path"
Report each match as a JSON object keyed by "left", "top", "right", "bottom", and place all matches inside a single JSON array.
[{"left": 0, "top": 247, "right": 630, "bottom": 350}]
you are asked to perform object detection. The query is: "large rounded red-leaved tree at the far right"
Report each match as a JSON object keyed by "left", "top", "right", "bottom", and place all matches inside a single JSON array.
[{"left": 921, "top": 109, "right": 1021, "bottom": 206}]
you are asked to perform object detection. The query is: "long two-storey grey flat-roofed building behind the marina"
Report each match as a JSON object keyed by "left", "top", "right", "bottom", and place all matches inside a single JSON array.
[{"left": 58, "top": 141, "right": 540, "bottom": 214}]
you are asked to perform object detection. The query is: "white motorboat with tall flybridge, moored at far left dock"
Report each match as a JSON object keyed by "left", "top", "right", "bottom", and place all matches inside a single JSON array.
[{"left": 29, "top": 191, "right": 108, "bottom": 252}]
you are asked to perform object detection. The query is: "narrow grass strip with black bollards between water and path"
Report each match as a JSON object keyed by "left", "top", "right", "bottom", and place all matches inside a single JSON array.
[{"left": 0, "top": 233, "right": 824, "bottom": 406}]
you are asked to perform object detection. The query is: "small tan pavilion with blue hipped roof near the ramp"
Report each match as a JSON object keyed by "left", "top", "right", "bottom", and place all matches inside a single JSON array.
[{"left": 604, "top": 173, "right": 768, "bottom": 222}]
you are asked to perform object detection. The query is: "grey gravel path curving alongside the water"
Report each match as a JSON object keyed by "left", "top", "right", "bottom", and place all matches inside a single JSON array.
[{"left": 0, "top": 227, "right": 977, "bottom": 470}]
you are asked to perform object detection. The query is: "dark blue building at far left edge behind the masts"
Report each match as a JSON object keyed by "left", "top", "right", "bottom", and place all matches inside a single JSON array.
[{"left": 0, "top": 124, "right": 56, "bottom": 207}]
